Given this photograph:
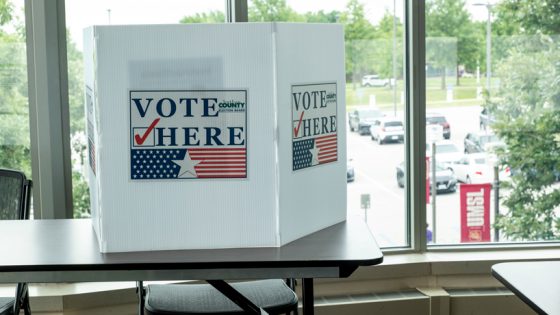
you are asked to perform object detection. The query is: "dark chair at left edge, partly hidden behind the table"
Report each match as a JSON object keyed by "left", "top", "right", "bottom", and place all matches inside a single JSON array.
[{"left": 0, "top": 169, "right": 32, "bottom": 315}]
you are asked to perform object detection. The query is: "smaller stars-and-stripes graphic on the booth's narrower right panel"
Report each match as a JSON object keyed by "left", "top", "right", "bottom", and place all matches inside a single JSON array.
[{"left": 292, "top": 133, "right": 338, "bottom": 171}]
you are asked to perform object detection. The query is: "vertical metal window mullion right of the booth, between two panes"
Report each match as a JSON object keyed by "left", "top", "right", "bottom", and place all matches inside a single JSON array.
[{"left": 405, "top": 0, "right": 427, "bottom": 252}]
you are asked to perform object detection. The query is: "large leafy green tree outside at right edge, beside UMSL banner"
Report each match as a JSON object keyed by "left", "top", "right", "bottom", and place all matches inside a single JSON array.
[{"left": 485, "top": 0, "right": 560, "bottom": 240}]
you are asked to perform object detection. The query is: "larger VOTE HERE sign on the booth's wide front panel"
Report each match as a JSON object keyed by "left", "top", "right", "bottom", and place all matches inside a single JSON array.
[{"left": 129, "top": 90, "right": 247, "bottom": 180}]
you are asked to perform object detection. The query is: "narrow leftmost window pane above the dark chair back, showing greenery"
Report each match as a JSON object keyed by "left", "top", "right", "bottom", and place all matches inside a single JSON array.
[{"left": 0, "top": 1, "right": 31, "bottom": 178}]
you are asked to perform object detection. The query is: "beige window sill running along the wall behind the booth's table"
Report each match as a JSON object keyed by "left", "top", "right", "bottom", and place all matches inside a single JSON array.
[{"left": 0, "top": 248, "right": 560, "bottom": 311}]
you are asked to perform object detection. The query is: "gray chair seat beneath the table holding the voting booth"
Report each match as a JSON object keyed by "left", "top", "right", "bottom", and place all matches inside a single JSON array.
[{"left": 138, "top": 279, "right": 298, "bottom": 315}]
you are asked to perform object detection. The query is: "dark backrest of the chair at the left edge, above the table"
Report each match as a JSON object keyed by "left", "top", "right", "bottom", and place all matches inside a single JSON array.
[{"left": 0, "top": 169, "right": 31, "bottom": 220}]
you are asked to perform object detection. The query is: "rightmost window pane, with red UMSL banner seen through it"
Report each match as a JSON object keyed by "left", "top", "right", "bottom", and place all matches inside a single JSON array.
[{"left": 426, "top": 0, "right": 560, "bottom": 244}]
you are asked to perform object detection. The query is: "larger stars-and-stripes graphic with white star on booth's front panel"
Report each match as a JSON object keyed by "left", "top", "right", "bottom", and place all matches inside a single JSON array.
[{"left": 130, "top": 147, "right": 247, "bottom": 180}]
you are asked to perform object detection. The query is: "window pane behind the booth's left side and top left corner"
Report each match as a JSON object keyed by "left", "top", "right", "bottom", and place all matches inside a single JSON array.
[{"left": 67, "top": 0, "right": 225, "bottom": 217}]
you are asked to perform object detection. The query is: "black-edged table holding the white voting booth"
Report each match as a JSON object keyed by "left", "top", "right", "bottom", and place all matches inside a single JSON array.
[{"left": 0, "top": 218, "right": 383, "bottom": 314}]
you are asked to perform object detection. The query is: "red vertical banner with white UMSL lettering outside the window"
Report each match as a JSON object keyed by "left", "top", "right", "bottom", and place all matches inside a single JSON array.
[{"left": 460, "top": 184, "right": 491, "bottom": 243}]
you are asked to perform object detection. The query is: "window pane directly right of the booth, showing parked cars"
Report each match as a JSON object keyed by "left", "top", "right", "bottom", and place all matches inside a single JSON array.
[{"left": 252, "top": 0, "right": 409, "bottom": 247}]
